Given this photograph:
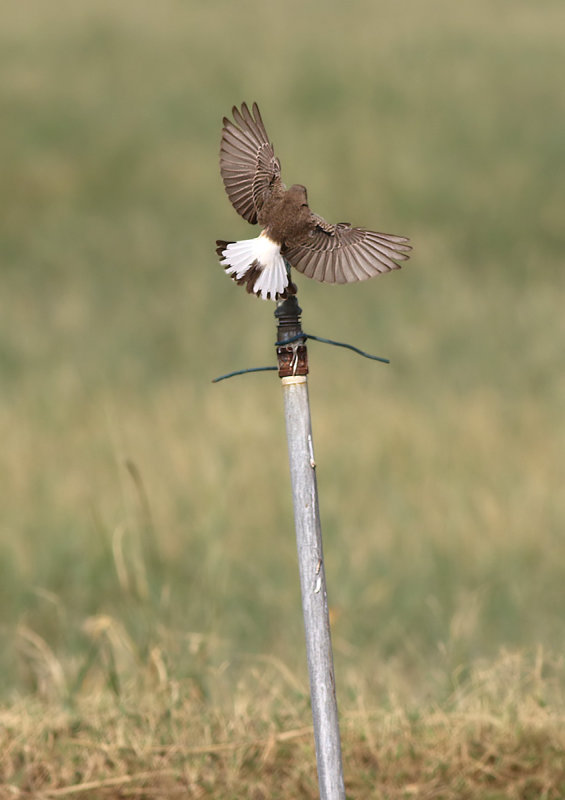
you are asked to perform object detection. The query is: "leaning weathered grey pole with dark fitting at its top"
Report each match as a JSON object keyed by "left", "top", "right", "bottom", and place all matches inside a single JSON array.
[{"left": 275, "top": 296, "right": 345, "bottom": 800}]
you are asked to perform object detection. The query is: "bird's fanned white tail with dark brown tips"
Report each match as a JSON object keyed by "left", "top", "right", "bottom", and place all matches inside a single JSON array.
[{"left": 216, "top": 233, "right": 296, "bottom": 300}]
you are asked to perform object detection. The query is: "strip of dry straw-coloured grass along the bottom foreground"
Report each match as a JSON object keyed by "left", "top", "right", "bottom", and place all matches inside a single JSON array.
[{"left": 0, "top": 653, "right": 565, "bottom": 800}]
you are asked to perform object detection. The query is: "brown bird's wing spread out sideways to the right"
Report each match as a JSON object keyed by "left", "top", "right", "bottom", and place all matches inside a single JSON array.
[{"left": 283, "top": 215, "right": 412, "bottom": 283}]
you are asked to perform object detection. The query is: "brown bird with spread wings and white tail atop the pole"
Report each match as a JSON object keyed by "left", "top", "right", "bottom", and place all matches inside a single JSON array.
[{"left": 216, "top": 103, "right": 412, "bottom": 301}]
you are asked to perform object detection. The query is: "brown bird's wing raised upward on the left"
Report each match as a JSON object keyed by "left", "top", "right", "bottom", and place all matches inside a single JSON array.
[{"left": 220, "top": 103, "right": 281, "bottom": 225}]
